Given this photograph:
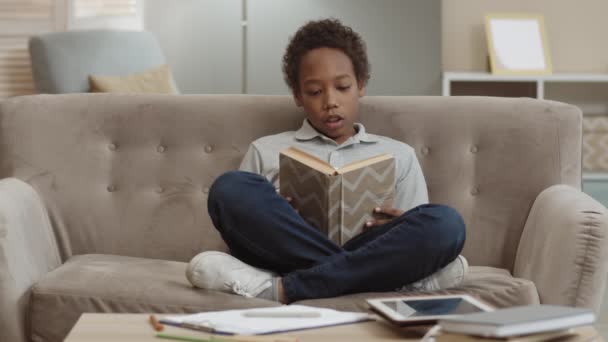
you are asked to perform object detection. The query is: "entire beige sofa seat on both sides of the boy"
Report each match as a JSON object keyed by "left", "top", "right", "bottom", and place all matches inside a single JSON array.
[{"left": 30, "top": 254, "right": 539, "bottom": 341}]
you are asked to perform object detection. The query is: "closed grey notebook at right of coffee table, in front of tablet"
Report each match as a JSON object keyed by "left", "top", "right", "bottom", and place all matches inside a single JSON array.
[{"left": 439, "top": 305, "right": 595, "bottom": 337}]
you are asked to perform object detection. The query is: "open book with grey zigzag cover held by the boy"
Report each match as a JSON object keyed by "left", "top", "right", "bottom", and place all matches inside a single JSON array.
[{"left": 279, "top": 147, "right": 395, "bottom": 245}]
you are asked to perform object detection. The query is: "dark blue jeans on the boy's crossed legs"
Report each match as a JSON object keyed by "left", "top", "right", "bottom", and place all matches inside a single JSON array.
[{"left": 208, "top": 171, "right": 465, "bottom": 302}]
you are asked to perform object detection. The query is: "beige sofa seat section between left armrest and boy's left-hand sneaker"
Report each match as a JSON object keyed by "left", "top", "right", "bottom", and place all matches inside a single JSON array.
[{"left": 30, "top": 254, "right": 279, "bottom": 342}]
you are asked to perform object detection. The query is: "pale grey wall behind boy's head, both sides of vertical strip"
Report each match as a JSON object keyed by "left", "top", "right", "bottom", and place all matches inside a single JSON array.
[{"left": 145, "top": 0, "right": 441, "bottom": 95}]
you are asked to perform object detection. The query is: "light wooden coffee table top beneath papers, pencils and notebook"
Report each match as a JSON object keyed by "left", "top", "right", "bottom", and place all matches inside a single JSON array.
[{"left": 65, "top": 313, "right": 603, "bottom": 342}]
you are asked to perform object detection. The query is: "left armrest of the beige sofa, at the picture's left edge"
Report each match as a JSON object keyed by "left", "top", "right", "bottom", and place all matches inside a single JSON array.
[{"left": 0, "top": 178, "right": 61, "bottom": 342}]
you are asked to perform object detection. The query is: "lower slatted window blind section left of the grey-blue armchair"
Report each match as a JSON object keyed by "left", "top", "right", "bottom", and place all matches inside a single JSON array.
[{"left": 0, "top": 36, "right": 35, "bottom": 98}]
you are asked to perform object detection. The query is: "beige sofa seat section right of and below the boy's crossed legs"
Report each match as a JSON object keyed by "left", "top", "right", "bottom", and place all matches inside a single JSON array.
[{"left": 296, "top": 266, "right": 540, "bottom": 311}]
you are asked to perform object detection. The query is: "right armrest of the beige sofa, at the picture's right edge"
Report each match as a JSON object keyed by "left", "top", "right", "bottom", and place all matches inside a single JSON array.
[{"left": 513, "top": 185, "right": 608, "bottom": 312}]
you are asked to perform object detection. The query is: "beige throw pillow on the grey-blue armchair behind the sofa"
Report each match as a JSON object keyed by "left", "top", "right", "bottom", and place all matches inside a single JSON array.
[{"left": 89, "top": 64, "right": 179, "bottom": 94}]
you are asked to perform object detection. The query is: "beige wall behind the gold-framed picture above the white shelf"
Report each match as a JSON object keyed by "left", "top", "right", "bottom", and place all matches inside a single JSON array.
[{"left": 442, "top": 0, "right": 608, "bottom": 73}]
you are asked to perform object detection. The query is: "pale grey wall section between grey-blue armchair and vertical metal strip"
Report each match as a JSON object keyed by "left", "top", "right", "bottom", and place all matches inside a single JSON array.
[{"left": 144, "top": 0, "right": 242, "bottom": 94}]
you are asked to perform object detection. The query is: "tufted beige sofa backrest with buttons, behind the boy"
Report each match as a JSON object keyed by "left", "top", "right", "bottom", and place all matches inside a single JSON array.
[{"left": 0, "top": 94, "right": 581, "bottom": 269}]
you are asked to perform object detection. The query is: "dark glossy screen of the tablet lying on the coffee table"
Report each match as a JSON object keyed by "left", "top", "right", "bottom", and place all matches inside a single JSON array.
[{"left": 382, "top": 298, "right": 483, "bottom": 317}]
